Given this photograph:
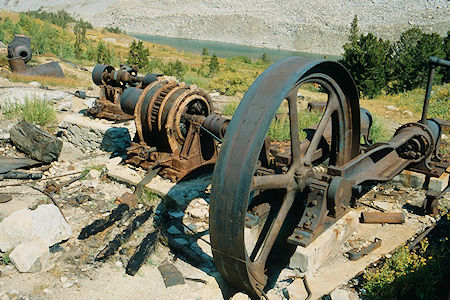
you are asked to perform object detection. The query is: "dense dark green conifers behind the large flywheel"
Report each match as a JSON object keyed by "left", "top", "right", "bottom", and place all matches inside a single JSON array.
[{"left": 340, "top": 16, "right": 450, "bottom": 98}]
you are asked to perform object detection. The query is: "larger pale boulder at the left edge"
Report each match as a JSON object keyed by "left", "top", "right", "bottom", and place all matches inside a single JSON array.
[{"left": 0, "top": 204, "right": 72, "bottom": 252}]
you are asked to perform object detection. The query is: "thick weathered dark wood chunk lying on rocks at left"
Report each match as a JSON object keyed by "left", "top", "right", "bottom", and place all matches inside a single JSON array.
[{"left": 9, "top": 121, "right": 62, "bottom": 163}]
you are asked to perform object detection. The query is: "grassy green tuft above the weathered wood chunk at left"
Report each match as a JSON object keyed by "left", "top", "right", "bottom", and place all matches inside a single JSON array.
[{"left": 2, "top": 98, "right": 56, "bottom": 126}]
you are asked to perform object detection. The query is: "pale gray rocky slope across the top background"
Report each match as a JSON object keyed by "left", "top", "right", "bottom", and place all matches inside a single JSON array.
[{"left": 0, "top": 0, "right": 450, "bottom": 54}]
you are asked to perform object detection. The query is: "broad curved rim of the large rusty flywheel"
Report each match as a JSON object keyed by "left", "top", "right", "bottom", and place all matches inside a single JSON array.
[{"left": 210, "top": 57, "right": 359, "bottom": 296}]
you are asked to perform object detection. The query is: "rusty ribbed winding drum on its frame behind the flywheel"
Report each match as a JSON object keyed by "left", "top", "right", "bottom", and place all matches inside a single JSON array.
[{"left": 116, "top": 74, "right": 229, "bottom": 181}]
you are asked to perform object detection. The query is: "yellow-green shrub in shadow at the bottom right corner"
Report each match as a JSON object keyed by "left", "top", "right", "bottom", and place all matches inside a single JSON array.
[{"left": 360, "top": 213, "right": 450, "bottom": 300}]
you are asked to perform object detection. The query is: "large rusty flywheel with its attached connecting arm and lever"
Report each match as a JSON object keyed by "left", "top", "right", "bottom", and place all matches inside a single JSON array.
[{"left": 209, "top": 57, "right": 449, "bottom": 297}]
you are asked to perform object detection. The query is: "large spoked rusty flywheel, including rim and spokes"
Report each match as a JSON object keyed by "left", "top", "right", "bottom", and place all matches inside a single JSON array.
[{"left": 209, "top": 57, "right": 360, "bottom": 296}]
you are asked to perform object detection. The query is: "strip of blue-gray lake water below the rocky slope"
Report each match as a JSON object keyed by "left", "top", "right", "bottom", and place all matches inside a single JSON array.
[{"left": 132, "top": 34, "right": 337, "bottom": 62}]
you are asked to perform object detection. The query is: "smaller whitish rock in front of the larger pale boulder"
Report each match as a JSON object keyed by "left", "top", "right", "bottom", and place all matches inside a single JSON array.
[{"left": 9, "top": 238, "right": 50, "bottom": 273}]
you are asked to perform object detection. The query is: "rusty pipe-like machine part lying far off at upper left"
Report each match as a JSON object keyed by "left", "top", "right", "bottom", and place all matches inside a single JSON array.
[{"left": 8, "top": 34, "right": 64, "bottom": 78}]
